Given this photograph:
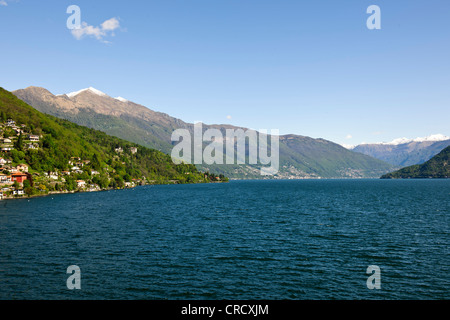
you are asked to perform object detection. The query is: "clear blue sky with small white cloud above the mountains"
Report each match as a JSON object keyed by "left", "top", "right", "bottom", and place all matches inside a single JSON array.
[{"left": 0, "top": 0, "right": 450, "bottom": 145}]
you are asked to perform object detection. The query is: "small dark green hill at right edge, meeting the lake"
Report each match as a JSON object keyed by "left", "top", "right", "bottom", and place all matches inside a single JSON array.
[{"left": 381, "top": 146, "right": 450, "bottom": 179}]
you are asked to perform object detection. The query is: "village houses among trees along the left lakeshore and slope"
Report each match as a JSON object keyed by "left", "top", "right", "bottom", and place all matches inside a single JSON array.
[{"left": 0, "top": 119, "right": 224, "bottom": 200}]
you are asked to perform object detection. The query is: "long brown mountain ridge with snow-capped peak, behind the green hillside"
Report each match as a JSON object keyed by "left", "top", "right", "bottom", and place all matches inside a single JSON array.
[{"left": 13, "top": 87, "right": 393, "bottom": 178}]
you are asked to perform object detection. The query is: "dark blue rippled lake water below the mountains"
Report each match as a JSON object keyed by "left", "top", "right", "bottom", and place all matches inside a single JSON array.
[{"left": 0, "top": 180, "right": 450, "bottom": 299}]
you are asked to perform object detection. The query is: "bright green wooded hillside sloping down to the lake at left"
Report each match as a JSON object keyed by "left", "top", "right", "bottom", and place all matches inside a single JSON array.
[{"left": 0, "top": 88, "right": 224, "bottom": 194}]
